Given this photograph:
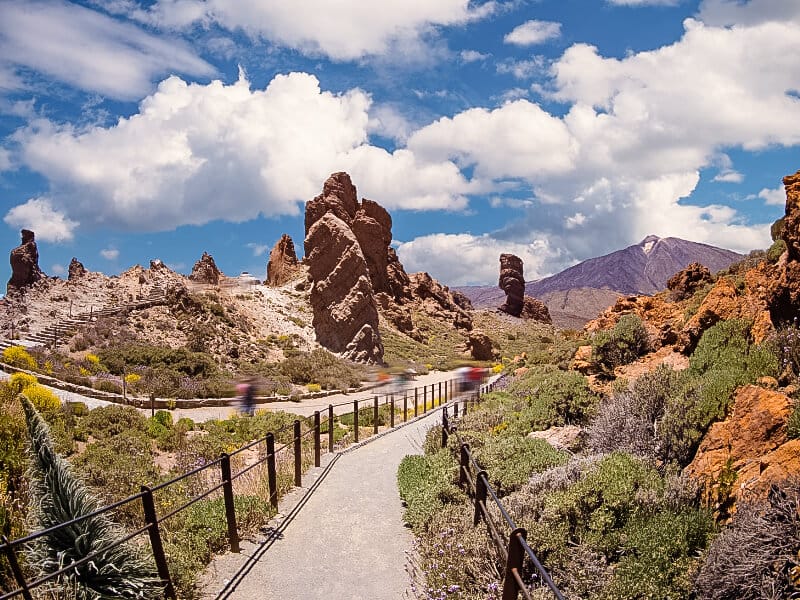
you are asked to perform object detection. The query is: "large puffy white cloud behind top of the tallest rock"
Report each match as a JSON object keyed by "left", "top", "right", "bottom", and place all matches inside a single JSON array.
[{"left": 14, "top": 73, "right": 471, "bottom": 231}]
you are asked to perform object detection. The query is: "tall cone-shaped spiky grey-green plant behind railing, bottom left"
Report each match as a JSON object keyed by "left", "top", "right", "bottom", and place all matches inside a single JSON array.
[{"left": 20, "top": 394, "right": 163, "bottom": 600}]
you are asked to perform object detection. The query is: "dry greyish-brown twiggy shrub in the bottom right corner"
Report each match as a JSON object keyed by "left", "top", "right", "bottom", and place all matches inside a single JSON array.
[{"left": 695, "top": 481, "right": 800, "bottom": 600}]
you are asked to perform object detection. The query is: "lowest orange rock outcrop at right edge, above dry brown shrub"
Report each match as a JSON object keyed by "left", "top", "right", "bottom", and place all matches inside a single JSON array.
[{"left": 686, "top": 385, "right": 800, "bottom": 508}]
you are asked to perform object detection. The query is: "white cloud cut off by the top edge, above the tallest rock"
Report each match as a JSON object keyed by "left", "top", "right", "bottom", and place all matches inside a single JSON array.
[{"left": 139, "top": 0, "right": 497, "bottom": 61}]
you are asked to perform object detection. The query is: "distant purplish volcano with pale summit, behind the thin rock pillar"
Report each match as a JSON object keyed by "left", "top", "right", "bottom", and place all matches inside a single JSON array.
[{"left": 456, "top": 235, "right": 742, "bottom": 327}]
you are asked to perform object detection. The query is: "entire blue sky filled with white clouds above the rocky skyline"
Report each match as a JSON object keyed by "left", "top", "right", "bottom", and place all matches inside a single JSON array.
[{"left": 0, "top": 0, "right": 800, "bottom": 285}]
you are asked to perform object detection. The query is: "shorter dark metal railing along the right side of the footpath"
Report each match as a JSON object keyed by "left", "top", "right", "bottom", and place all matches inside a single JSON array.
[{"left": 442, "top": 384, "right": 564, "bottom": 600}]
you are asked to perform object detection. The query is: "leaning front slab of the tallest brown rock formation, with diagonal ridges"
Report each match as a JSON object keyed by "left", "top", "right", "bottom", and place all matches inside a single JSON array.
[{"left": 305, "top": 213, "right": 383, "bottom": 363}]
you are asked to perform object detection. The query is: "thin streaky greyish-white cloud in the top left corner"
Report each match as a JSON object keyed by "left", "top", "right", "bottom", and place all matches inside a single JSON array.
[{"left": 0, "top": 0, "right": 214, "bottom": 100}]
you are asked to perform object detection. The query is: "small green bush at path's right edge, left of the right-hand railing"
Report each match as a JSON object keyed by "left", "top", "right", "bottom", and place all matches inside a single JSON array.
[{"left": 397, "top": 448, "right": 466, "bottom": 531}]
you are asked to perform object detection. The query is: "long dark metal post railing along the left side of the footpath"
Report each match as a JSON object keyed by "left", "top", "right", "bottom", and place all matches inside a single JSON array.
[{"left": 0, "top": 379, "right": 456, "bottom": 600}]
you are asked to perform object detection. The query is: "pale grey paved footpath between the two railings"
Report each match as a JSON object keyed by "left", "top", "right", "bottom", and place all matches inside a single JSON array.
[{"left": 196, "top": 410, "right": 441, "bottom": 600}]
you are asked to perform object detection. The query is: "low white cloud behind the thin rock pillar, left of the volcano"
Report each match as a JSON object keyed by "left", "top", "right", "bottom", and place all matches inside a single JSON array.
[{"left": 397, "top": 233, "right": 560, "bottom": 286}]
